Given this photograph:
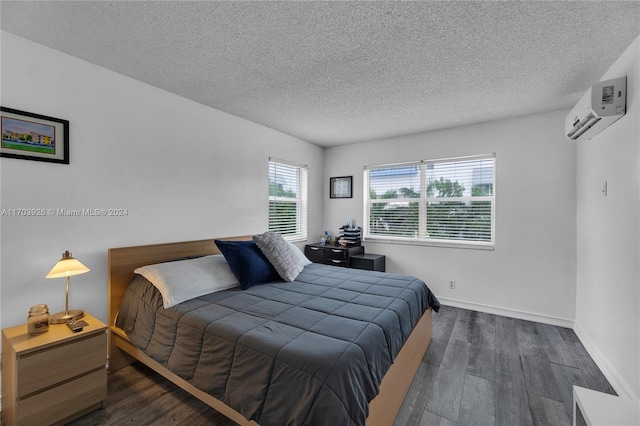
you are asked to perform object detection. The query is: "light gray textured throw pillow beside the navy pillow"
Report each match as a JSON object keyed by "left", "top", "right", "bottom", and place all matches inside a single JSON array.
[{"left": 252, "top": 231, "right": 304, "bottom": 281}]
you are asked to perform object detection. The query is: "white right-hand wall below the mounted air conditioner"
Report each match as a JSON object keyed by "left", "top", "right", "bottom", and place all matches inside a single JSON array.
[{"left": 576, "top": 38, "right": 640, "bottom": 398}]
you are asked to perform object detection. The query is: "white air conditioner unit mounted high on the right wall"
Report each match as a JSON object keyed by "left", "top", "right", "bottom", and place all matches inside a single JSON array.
[{"left": 564, "top": 77, "right": 627, "bottom": 141}]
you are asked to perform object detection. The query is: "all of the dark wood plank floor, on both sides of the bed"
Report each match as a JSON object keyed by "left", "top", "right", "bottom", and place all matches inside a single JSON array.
[{"left": 66, "top": 306, "right": 615, "bottom": 426}]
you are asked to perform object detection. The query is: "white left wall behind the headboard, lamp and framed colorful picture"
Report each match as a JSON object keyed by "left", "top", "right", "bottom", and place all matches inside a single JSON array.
[{"left": 0, "top": 32, "right": 323, "bottom": 327}]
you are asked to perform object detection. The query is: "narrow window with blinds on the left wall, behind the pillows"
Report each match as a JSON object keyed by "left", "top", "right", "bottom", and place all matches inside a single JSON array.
[{"left": 269, "top": 158, "right": 307, "bottom": 241}]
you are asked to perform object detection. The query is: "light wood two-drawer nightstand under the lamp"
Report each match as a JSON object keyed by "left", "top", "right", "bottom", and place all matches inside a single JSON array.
[{"left": 2, "top": 314, "right": 107, "bottom": 426}]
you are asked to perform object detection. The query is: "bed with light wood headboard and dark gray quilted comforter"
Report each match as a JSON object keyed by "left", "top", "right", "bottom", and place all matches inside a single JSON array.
[{"left": 109, "top": 236, "right": 439, "bottom": 426}]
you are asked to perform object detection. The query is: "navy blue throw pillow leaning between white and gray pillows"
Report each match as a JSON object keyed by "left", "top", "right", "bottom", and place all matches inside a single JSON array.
[{"left": 214, "top": 240, "right": 281, "bottom": 290}]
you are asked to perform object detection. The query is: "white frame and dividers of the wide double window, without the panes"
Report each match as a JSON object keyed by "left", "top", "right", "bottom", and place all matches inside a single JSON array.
[{"left": 363, "top": 153, "right": 496, "bottom": 250}]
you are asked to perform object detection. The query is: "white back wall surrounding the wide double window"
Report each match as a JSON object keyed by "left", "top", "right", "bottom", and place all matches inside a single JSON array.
[{"left": 324, "top": 111, "right": 576, "bottom": 326}]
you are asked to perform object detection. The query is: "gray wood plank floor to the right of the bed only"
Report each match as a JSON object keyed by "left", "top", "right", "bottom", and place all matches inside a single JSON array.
[{"left": 395, "top": 306, "right": 615, "bottom": 426}]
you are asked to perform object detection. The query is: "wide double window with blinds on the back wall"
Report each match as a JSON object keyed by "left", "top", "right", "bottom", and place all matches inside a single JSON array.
[{"left": 364, "top": 154, "right": 495, "bottom": 247}]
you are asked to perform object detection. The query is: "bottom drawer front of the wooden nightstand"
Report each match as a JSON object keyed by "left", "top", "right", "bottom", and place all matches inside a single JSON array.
[{"left": 17, "top": 366, "right": 107, "bottom": 425}]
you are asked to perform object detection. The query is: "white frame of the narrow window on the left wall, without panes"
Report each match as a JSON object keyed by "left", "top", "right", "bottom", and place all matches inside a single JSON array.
[{"left": 267, "top": 157, "right": 309, "bottom": 242}]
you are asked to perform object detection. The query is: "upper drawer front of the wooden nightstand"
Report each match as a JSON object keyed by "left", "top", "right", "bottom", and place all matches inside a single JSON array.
[{"left": 17, "top": 332, "right": 107, "bottom": 398}]
